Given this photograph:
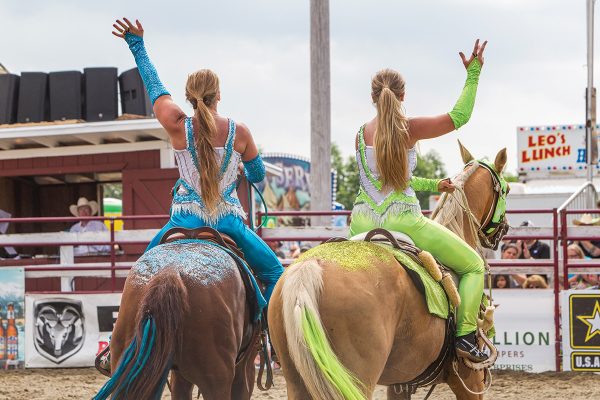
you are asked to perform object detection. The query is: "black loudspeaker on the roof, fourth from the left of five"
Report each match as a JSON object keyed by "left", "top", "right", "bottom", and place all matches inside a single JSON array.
[{"left": 83, "top": 67, "right": 118, "bottom": 121}]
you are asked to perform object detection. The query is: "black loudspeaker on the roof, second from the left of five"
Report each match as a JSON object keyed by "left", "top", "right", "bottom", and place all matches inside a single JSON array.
[{"left": 17, "top": 72, "right": 50, "bottom": 122}]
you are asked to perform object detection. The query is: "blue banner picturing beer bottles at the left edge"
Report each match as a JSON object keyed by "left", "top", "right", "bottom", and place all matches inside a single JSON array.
[{"left": 0, "top": 268, "right": 25, "bottom": 369}]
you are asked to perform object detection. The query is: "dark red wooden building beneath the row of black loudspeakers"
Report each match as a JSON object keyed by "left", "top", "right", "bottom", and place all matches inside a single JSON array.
[{"left": 0, "top": 117, "right": 281, "bottom": 290}]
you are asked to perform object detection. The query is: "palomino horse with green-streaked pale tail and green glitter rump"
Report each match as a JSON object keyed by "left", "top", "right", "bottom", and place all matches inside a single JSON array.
[{"left": 269, "top": 145, "right": 506, "bottom": 400}]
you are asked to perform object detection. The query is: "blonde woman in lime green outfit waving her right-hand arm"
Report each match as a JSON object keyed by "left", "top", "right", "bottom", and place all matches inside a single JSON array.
[{"left": 350, "top": 40, "right": 487, "bottom": 361}]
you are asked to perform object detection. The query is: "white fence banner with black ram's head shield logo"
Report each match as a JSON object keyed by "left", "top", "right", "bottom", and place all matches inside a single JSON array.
[{"left": 25, "top": 293, "right": 121, "bottom": 368}]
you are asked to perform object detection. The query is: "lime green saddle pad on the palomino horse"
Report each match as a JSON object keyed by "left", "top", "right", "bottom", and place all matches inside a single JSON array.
[{"left": 377, "top": 244, "right": 450, "bottom": 319}]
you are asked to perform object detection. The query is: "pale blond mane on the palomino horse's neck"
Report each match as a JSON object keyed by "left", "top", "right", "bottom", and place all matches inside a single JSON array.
[{"left": 432, "top": 161, "right": 479, "bottom": 239}]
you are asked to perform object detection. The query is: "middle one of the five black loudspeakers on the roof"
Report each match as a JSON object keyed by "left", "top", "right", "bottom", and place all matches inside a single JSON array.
[{"left": 49, "top": 71, "right": 83, "bottom": 121}]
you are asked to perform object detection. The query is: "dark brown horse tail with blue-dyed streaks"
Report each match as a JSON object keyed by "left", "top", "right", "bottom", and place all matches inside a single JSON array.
[{"left": 93, "top": 268, "right": 189, "bottom": 400}]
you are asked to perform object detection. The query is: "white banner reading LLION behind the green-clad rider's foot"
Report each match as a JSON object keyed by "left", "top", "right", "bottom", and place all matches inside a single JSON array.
[{"left": 493, "top": 289, "right": 556, "bottom": 372}]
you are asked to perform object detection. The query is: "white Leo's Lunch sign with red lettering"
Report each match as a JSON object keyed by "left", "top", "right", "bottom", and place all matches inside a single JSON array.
[{"left": 517, "top": 125, "right": 598, "bottom": 179}]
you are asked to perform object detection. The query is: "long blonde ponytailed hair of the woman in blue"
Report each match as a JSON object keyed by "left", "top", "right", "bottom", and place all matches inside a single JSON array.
[{"left": 186, "top": 69, "right": 221, "bottom": 214}]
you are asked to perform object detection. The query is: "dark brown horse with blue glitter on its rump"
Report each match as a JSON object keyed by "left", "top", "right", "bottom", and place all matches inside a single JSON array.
[{"left": 95, "top": 241, "right": 258, "bottom": 400}]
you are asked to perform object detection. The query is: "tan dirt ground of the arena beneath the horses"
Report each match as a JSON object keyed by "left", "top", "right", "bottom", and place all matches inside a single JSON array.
[{"left": 0, "top": 368, "right": 600, "bottom": 400}]
